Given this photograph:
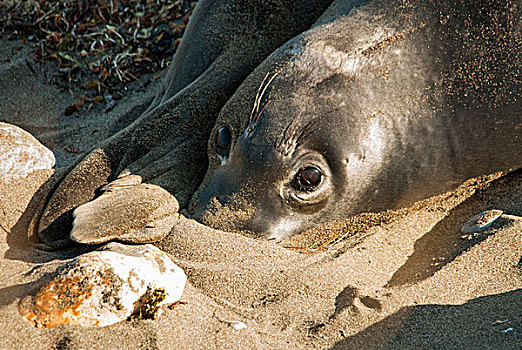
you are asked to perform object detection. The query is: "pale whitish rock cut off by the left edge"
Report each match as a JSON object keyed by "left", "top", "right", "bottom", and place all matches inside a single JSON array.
[{"left": 0, "top": 123, "right": 55, "bottom": 181}]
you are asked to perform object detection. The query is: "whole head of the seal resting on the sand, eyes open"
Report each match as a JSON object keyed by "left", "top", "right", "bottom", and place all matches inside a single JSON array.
[{"left": 189, "top": 23, "right": 404, "bottom": 239}]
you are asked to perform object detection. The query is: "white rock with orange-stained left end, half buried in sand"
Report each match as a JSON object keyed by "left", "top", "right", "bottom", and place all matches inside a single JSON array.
[{"left": 19, "top": 243, "right": 187, "bottom": 328}]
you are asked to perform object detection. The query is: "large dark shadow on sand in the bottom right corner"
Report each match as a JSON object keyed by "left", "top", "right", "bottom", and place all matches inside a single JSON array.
[{"left": 332, "top": 289, "right": 522, "bottom": 350}]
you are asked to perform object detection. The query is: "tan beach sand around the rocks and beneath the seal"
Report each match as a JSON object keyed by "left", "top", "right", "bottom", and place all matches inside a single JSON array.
[{"left": 0, "top": 36, "right": 522, "bottom": 349}]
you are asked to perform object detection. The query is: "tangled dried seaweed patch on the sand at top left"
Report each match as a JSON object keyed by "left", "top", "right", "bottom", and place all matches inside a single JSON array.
[{"left": 0, "top": 0, "right": 196, "bottom": 114}]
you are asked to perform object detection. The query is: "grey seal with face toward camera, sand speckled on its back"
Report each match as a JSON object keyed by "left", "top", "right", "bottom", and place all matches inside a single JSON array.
[{"left": 189, "top": 1, "right": 522, "bottom": 239}]
